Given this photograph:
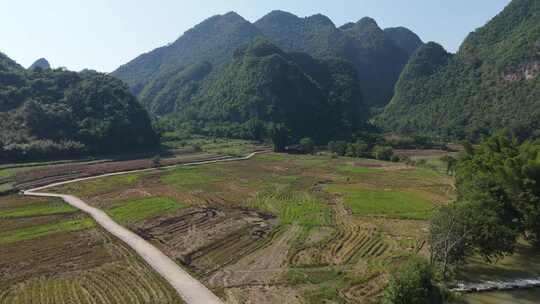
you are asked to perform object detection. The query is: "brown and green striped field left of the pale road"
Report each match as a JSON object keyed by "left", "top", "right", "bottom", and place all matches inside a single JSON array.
[{"left": 0, "top": 196, "right": 183, "bottom": 304}]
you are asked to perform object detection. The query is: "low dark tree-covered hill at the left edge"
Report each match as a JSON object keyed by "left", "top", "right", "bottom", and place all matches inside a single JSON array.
[{"left": 0, "top": 55, "right": 157, "bottom": 159}]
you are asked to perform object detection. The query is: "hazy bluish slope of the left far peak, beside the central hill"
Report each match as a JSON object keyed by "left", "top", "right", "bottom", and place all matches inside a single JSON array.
[{"left": 112, "top": 12, "right": 260, "bottom": 115}]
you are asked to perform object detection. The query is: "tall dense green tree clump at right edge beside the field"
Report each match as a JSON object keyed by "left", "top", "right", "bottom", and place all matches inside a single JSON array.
[{"left": 430, "top": 135, "right": 540, "bottom": 273}]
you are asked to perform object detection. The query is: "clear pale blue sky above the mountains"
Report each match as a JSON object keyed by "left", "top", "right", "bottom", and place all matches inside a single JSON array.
[{"left": 0, "top": 0, "right": 510, "bottom": 72}]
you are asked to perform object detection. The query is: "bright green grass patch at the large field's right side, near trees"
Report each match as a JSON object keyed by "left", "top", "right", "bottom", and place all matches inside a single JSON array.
[{"left": 325, "top": 185, "right": 433, "bottom": 220}]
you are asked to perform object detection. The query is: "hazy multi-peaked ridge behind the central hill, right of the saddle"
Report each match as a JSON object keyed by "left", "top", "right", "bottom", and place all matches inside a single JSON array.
[{"left": 255, "top": 11, "right": 416, "bottom": 106}]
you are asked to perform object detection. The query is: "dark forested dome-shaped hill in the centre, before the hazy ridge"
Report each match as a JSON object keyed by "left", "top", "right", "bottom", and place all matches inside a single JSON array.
[{"left": 179, "top": 38, "right": 367, "bottom": 141}]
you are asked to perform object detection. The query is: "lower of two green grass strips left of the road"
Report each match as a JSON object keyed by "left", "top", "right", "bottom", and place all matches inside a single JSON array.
[{"left": 0, "top": 218, "right": 95, "bottom": 244}]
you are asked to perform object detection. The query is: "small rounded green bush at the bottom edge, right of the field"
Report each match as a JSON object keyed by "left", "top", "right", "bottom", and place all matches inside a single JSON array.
[{"left": 383, "top": 259, "right": 443, "bottom": 304}]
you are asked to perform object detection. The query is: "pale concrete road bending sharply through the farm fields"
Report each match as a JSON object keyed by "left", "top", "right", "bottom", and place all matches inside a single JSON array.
[{"left": 23, "top": 152, "right": 265, "bottom": 304}]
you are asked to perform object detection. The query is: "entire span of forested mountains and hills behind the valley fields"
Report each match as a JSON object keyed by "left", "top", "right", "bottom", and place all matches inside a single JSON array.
[{"left": 0, "top": 0, "right": 540, "bottom": 159}]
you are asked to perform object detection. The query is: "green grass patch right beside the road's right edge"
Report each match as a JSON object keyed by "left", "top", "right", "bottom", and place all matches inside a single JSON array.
[{"left": 106, "top": 197, "right": 186, "bottom": 223}]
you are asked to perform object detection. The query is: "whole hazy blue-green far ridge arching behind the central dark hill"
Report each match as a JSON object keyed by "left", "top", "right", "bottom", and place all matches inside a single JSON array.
[{"left": 112, "top": 11, "right": 422, "bottom": 116}]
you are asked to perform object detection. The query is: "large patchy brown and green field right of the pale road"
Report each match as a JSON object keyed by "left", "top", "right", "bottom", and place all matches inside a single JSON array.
[{"left": 46, "top": 154, "right": 454, "bottom": 303}]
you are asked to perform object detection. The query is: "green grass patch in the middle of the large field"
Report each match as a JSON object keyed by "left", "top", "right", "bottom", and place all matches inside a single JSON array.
[{"left": 248, "top": 187, "right": 332, "bottom": 228}]
